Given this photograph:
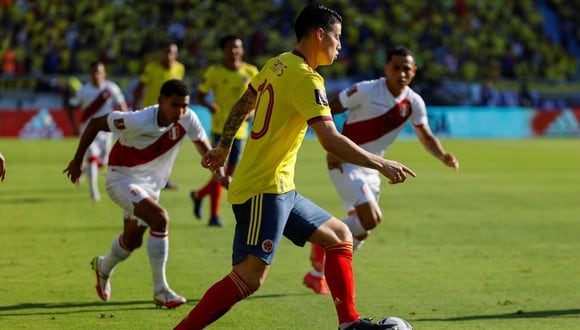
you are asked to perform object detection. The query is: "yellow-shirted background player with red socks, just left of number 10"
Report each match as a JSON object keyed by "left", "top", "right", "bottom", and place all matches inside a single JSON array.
[{"left": 190, "top": 34, "right": 258, "bottom": 227}]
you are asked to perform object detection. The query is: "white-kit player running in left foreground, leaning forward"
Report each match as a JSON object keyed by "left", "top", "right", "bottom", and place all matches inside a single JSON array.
[{"left": 64, "top": 79, "right": 223, "bottom": 308}]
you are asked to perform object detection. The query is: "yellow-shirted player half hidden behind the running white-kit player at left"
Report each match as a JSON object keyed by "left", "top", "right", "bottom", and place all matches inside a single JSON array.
[{"left": 133, "top": 41, "right": 185, "bottom": 190}]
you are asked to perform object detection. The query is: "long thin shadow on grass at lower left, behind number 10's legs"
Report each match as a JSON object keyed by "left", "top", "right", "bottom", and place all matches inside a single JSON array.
[{"left": 0, "top": 294, "right": 305, "bottom": 316}]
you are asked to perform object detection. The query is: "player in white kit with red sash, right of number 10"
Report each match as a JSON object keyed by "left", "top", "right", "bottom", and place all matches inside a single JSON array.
[{"left": 304, "top": 47, "right": 459, "bottom": 294}]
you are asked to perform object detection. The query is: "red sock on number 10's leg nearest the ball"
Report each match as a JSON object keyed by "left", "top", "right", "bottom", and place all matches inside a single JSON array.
[{"left": 324, "top": 242, "right": 360, "bottom": 324}]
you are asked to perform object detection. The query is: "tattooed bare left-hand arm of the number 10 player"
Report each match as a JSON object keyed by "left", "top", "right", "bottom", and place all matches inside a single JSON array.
[{"left": 202, "top": 88, "right": 257, "bottom": 171}]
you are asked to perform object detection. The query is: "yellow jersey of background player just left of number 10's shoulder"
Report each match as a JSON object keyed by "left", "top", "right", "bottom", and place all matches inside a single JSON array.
[{"left": 198, "top": 63, "right": 258, "bottom": 139}]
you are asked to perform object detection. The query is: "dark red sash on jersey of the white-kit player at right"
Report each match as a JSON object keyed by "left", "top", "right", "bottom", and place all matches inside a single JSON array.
[{"left": 342, "top": 99, "right": 413, "bottom": 145}]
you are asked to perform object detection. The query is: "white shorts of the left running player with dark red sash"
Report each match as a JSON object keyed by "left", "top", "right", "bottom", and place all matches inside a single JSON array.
[{"left": 106, "top": 169, "right": 161, "bottom": 226}]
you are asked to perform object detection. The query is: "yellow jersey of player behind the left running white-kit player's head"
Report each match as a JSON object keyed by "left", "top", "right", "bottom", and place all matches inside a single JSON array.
[{"left": 139, "top": 61, "right": 185, "bottom": 108}]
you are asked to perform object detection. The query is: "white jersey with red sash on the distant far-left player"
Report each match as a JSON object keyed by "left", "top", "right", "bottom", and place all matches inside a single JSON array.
[{"left": 69, "top": 80, "right": 125, "bottom": 130}]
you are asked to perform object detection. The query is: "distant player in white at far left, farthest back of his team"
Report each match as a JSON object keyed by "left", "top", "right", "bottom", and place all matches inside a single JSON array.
[{"left": 67, "top": 61, "right": 127, "bottom": 201}]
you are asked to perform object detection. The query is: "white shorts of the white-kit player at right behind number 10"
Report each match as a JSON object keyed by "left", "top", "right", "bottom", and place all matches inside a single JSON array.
[{"left": 329, "top": 163, "right": 381, "bottom": 212}]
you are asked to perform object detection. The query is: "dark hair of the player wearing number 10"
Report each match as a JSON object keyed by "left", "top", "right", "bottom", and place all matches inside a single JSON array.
[{"left": 294, "top": 3, "right": 342, "bottom": 41}]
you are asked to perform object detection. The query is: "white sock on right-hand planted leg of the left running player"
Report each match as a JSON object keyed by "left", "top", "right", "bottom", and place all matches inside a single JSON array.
[{"left": 147, "top": 231, "right": 169, "bottom": 293}]
